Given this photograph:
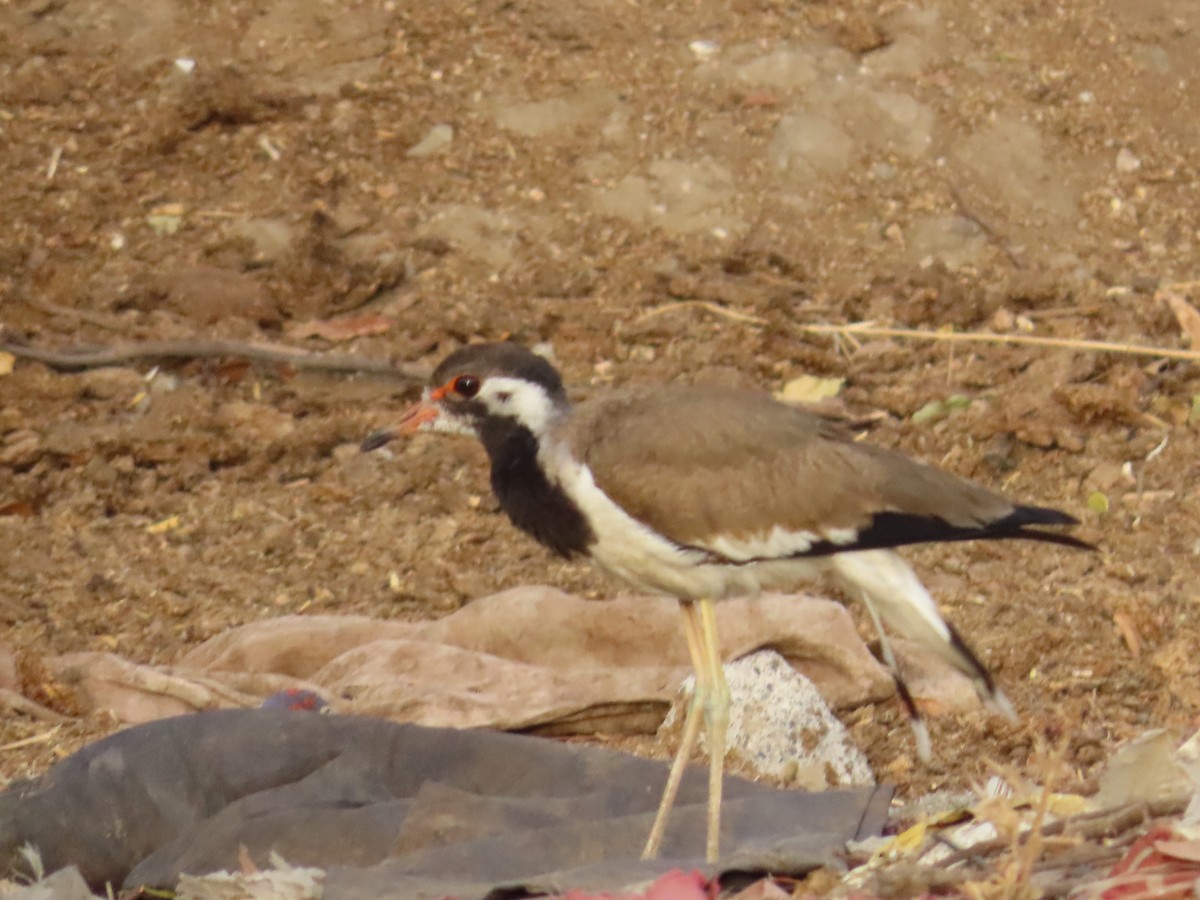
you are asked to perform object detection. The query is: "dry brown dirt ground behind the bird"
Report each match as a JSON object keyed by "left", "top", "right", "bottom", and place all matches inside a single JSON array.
[{"left": 0, "top": 0, "right": 1200, "bottom": 864}]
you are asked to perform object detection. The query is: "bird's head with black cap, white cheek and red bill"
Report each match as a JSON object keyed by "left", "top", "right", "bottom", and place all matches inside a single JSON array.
[{"left": 362, "top": 343, "right": 568, "bottom": 451}]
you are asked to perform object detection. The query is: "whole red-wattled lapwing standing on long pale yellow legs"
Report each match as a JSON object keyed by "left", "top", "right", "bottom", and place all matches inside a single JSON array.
[{"left": 362, "top": 343, "right": 1090, "bottom": 860}]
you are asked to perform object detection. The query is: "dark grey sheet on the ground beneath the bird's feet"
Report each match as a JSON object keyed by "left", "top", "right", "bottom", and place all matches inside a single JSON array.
[{"left": 0, "top": 709, "right": 892, "bottom": 900}]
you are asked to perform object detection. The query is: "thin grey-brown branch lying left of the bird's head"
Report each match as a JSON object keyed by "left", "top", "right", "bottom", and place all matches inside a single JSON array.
[{"left": 0, "top": 338, "right": 428, "bottom": 382}]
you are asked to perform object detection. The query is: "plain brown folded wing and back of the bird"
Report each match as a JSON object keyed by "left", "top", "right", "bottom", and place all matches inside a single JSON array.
[{"left": 566, "top": 386, "right": 1022, "bottom": 548}]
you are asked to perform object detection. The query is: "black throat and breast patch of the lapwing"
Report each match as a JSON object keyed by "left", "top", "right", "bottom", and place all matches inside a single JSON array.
[{"left": 479, "top": 416, "right": 595, "bottom": 559}]
